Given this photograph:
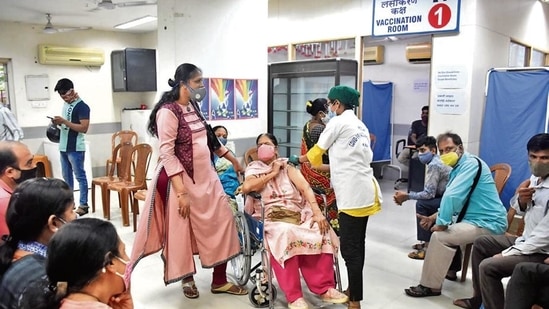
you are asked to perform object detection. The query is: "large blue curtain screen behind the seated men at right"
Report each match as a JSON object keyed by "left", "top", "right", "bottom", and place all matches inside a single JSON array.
[{"left": 480, "top": 71, "right": 549, "bottom": 207}]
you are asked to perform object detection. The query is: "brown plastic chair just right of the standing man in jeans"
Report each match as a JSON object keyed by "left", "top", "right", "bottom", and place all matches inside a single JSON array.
[{"left": 91, "top": 141, "right": 133, "bottom": 220}]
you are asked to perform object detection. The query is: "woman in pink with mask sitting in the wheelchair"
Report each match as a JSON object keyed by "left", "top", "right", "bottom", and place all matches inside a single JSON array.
[{"left": 242, "top": 133, "right": 348, "bottom": 309}]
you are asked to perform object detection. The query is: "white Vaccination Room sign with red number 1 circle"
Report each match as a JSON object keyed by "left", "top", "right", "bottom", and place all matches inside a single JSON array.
[{"left": 372, "top": 0, "right": 461, "bottom": 36}]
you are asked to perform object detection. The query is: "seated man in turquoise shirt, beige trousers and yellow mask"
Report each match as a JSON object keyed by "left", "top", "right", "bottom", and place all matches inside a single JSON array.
[{"left": 404, "top": 132, "right": 507, "bottom": 297}]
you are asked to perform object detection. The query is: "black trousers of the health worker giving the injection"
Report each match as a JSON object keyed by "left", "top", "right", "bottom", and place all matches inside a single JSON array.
[{"left": 339, "top": 212, "right": 369, "bottom": 301}]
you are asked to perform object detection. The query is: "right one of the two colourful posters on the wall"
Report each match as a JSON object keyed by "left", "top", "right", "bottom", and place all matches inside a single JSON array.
[{"left": 234, "top": 79, "right": 258, "bottom": 119}]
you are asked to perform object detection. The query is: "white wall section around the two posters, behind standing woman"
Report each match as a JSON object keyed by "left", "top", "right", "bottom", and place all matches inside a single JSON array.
[{"left": 158, "top": 0, "right": 267, "bottom": 140}]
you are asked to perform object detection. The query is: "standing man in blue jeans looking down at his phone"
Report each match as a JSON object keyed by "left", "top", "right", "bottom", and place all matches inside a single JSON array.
[{"left": 52, "top": 78, "right": 90, "bottom": 216}]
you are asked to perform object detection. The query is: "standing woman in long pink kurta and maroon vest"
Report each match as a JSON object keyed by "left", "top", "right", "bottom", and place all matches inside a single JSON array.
[{"left": 128, "top": 63, "right": 247, "bottom": 298}]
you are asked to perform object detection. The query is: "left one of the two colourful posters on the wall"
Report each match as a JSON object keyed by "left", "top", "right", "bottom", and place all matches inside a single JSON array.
[{"left": 210, "top": 78, "right": 234, "bottom": 120}]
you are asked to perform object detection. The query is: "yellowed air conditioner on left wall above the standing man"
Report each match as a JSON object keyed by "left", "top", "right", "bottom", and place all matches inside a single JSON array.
[{"left": 38, "top": 44, "right": 105, "bottom": 66}]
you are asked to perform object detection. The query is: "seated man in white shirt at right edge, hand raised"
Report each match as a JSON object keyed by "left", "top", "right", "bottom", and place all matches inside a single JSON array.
[{"left": 454, "top": 133, "right": 549, "bottom": 309}]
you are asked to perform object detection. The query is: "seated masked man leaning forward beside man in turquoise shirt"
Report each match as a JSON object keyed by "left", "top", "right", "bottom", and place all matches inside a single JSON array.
[{"left": 393, "top": 136, "right": 452, "bottom": 260}]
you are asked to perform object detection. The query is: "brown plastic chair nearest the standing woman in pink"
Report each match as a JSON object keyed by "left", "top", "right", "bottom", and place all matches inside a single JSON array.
[{"left": 106, "top": 144, "right": 152, "bottom": 226}]
